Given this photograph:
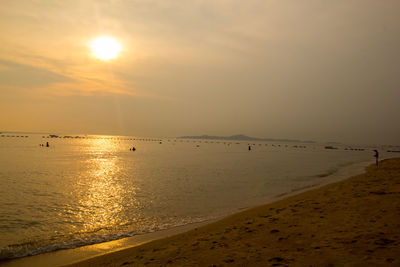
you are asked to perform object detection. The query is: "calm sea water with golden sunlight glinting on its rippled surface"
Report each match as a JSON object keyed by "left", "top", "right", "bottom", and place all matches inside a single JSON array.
[{"left": 0, "top": 134, "right": 384, "bottom": 259}]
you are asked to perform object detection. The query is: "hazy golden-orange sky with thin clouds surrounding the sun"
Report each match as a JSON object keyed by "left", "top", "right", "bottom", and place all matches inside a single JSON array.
[{"left": 0, "top": 0, "right": 400, "bottom": 145}]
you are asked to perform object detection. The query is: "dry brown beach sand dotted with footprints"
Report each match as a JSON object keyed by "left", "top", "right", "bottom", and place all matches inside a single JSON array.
[{"left": 67, "top": 159, "right": 400, "bottom": 266}]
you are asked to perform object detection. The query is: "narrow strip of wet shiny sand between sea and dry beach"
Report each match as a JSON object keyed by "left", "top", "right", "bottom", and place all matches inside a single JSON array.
[{"left": 0, "top": 158, "right": 388, "bottom": 266}]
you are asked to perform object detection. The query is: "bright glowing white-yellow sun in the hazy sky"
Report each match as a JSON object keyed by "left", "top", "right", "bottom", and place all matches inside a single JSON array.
[{"left": 90, "top": 36, "right": 122, "bottom": 60}]
